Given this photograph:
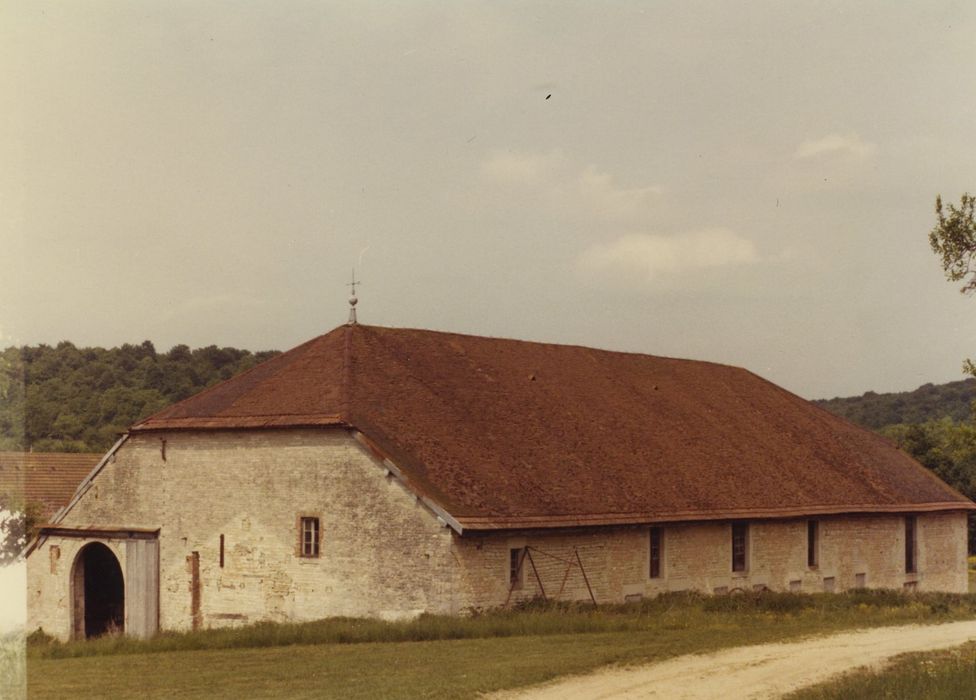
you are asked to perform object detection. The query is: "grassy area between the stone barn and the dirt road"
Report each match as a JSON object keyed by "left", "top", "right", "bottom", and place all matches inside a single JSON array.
[{"left": 27, "top": 591, "right": 976, "bottom": 699}]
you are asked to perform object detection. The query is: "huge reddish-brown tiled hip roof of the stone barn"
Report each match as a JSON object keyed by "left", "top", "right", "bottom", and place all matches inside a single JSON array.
[{"left": 132, "top": 326, "right": 976, "bottom": 530}]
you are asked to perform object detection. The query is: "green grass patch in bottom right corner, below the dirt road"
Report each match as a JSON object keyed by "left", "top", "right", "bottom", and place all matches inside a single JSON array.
[{"left": 788, "top": 643, "right": 976, "bottom": 700}]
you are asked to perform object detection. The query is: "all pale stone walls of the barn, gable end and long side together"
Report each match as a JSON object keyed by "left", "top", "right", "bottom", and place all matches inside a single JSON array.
[{"left": 28, "top": 430, "right": 967, "bottom": 639}]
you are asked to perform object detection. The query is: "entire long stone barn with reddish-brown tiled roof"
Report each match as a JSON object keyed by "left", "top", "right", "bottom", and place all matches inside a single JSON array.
[{"left": 22, "top": 324, "right": 976, "bottom": 639}]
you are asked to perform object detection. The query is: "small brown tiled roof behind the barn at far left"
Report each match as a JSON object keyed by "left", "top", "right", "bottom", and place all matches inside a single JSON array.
[{"left": 0, "top": 452, "right": 102, "bottom": 519}]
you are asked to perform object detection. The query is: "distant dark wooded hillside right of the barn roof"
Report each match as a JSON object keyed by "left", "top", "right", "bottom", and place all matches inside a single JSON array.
[{"left": 814, "top": 379, "right": 976, "bottom": 430}]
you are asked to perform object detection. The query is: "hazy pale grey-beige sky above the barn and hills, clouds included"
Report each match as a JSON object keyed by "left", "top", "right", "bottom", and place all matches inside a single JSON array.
[{"left": 0, "top": 0, "right": 976, "bottom": 398}]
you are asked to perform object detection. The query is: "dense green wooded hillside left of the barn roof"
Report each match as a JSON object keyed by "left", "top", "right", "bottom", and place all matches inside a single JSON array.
[{"left": 0, "top": 340, "right": 277, "bottom": 452}]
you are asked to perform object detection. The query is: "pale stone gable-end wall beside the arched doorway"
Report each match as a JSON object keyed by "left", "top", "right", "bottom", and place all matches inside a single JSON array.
[{"left": 28, "top": 431, "right": 456, "bottom": 638}]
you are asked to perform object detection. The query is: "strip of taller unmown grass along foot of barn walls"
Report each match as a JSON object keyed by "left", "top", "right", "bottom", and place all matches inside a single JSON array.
[{"left": 28, "top": 589, "right": 976, "bottom": 658}]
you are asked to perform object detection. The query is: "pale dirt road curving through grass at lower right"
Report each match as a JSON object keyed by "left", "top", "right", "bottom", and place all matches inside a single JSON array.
[{"left": 491, "top": 621, "right": 976, "bottom": 700}]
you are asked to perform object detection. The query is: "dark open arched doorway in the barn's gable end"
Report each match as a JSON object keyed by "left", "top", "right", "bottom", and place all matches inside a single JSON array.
[{"left": 71, "top": 542, "right": 125, "bottom": 639}]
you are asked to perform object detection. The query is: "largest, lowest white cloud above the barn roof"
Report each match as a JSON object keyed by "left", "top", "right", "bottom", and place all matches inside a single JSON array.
[{"left": 578, "top": 228, "right": 759, "bottom": 281}]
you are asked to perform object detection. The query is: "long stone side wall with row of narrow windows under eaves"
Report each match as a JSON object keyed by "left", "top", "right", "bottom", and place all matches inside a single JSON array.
[{"left": 455, "top": 513, "right": 968, "bottom": 608}]
